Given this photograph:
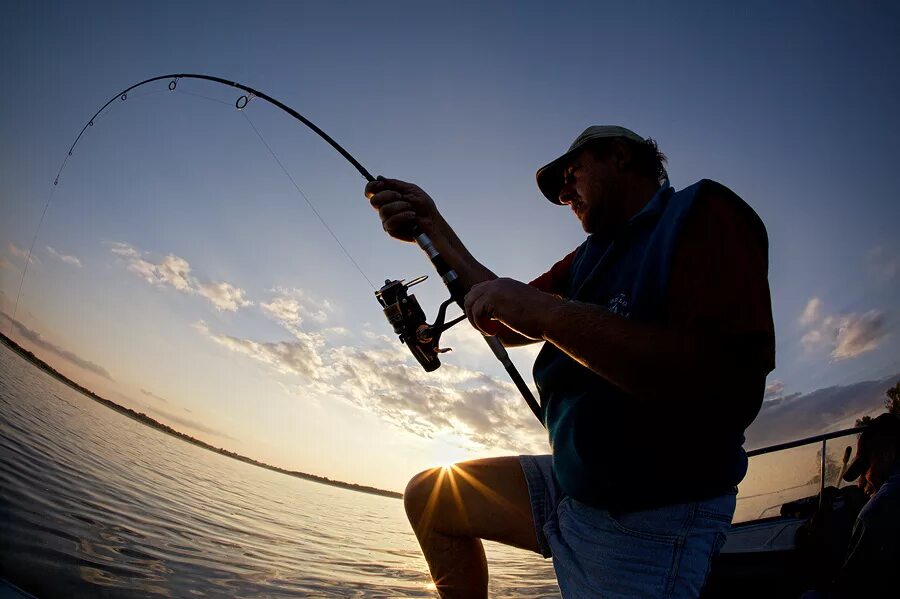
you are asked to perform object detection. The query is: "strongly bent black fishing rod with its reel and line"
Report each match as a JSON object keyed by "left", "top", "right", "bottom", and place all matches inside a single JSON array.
[{"left": 37, "top": 73, "right": 543, "bottom": 424}]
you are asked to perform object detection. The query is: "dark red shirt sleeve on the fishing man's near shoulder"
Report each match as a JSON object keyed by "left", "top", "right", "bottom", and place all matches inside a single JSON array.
[{"left": 668, "top": 186, "right": 775, "bottom": 373}]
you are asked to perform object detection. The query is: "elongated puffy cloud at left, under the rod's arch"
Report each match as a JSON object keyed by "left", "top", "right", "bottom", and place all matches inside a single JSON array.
[{"left": 110, "top": 241, "right": 253, "bottom": 312}]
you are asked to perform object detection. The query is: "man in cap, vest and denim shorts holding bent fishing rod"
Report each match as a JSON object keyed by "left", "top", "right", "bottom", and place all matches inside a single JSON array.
[{"left": 366, "top": 125, "right": 774, "bottom": 598}]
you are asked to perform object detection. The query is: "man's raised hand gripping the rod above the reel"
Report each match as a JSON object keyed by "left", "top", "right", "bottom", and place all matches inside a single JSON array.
[{"left": 366, "top": 177, "right": 443, "bottom": 241}]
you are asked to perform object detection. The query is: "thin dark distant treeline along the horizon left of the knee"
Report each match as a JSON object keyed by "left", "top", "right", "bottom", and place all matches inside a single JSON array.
[{"left": 0, "top": 333, "right": 403, "bottom": 499}]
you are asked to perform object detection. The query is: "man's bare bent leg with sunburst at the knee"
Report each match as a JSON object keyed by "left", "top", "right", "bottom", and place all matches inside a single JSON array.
[{"left": 403, "top": 457, "right": 540, "bottom": 598}]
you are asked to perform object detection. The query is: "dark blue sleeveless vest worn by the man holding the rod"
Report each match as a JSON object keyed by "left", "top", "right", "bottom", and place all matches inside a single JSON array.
[{"left": 534, "top": 179, "right": 767, "bottom": 510}]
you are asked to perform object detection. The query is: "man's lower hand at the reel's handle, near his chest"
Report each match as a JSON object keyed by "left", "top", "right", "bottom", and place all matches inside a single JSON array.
[{"left": 466, "top": 279, "right": 564, "bottom": 340}]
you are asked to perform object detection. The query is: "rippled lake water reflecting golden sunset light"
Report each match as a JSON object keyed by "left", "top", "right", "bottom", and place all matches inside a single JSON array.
[{"left": 0, "top": 344, "right": 559, "bottom": 598}]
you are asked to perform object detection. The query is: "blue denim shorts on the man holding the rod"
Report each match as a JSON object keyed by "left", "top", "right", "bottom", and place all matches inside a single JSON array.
[{"left": 519, "top": 455, "right": 736, "bottom": 599}]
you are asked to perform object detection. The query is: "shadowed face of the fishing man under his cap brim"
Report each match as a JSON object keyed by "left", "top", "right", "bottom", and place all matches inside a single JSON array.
[{"left": 559, "top": 149, "right": 622, "bottom": 233}]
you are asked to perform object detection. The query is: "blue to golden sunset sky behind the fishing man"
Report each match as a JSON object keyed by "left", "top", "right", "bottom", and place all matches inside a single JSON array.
[{"left": 0, "top": 0, "right": 900, "bottom": 490}]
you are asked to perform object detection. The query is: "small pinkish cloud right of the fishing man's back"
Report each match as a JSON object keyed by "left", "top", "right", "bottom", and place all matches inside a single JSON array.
[{"left": 799, "top": 298, "right": 889, "bottom": 361}]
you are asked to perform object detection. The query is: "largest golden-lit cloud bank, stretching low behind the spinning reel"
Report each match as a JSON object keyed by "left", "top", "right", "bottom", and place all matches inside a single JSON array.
[{"left": 194, "top": 321, "right": 548, "bottom": 452}]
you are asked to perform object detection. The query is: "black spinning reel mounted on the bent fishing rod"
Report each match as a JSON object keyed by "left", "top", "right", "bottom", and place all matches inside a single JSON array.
[{"left": 375, "top": 275, "right": 466, "bottom": 372}]
